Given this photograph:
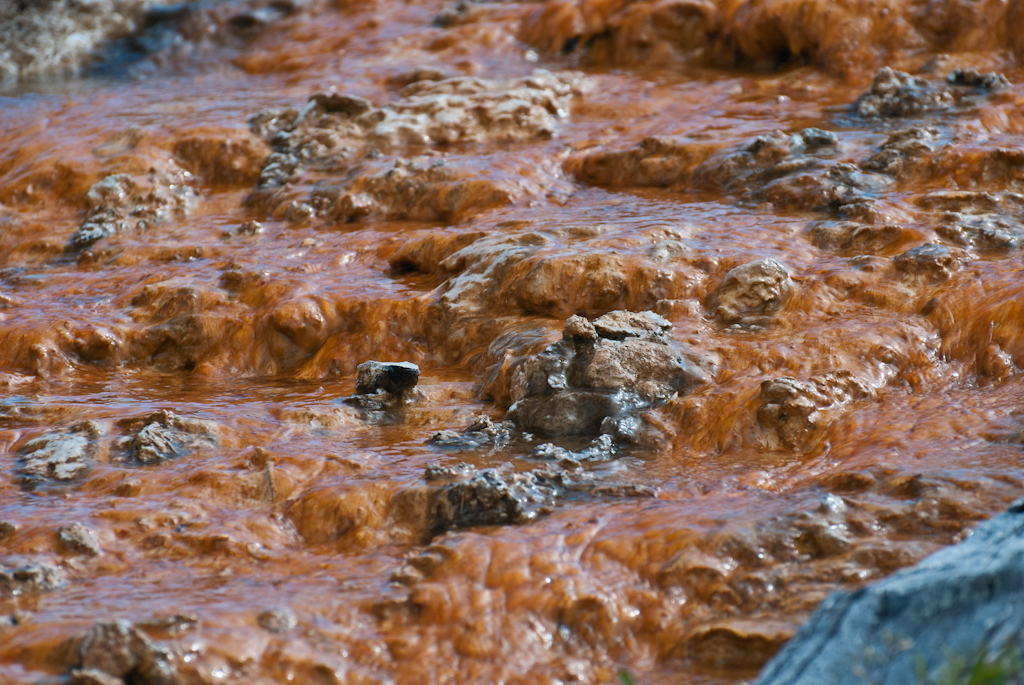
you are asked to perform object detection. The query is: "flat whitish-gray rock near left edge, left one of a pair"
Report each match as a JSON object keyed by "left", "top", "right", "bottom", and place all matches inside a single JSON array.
[{"left": 18, "top": 421, "right": 103, "bottom": 485}]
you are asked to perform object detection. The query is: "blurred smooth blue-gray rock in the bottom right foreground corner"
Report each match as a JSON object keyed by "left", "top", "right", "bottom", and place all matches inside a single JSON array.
[{"left": 757, "top": 500, "right": 1024, "bottom": 685}]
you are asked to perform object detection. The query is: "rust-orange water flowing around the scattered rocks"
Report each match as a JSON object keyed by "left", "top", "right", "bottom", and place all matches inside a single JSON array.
[{"left": 0, "top": 0, "right": 1024, "bottom": 685}]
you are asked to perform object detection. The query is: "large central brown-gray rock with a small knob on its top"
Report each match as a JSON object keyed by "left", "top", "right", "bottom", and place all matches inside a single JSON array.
[{"left": 506, "top": 311, "right": 710, "bottom": 441}]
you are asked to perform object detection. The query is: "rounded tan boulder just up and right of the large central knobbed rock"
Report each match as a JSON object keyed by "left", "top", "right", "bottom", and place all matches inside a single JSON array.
[{"left": 706, "top": 258, "right": 793, "bottom": 326}]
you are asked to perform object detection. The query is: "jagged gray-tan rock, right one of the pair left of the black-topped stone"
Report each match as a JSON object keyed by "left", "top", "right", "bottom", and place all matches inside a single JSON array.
[{"left": 118, "top": 410, "right": 217, "bottom": 464}]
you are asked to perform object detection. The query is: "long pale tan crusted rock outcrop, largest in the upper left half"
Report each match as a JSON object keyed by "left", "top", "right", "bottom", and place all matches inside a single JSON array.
[{"left": 250, "top": 70, "right": 589, "bottom": 222}]
